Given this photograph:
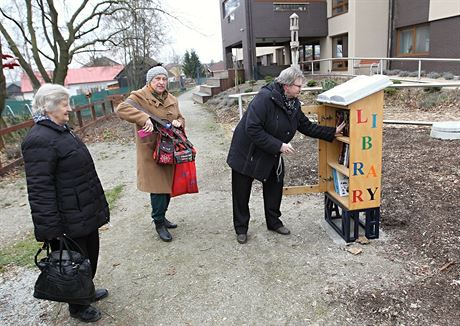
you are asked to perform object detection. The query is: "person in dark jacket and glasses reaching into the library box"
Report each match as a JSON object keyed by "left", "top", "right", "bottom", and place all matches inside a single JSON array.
[{"left": 227, "top": 67, "right": 344, "bottom": 243}]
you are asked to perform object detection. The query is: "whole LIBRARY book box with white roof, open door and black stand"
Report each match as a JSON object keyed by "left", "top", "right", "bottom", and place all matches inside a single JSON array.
[{"left": 284, "top": 75, "right": 392, "bottom": 242}]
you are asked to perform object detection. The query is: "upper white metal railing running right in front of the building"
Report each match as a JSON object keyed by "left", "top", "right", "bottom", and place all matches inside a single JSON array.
[{"left": 300, "top": 57, "right": 460, "bottom": 80}]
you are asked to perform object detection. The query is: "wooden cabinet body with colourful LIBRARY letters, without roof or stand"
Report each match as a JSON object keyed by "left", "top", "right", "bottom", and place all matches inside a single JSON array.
[{"left": 320, "top": 91, "right": 383, "bottom": 210}]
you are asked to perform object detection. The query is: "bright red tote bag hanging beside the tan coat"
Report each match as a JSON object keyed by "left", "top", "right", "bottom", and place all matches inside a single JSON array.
[{"left": 171, "top": 161, "right": 198, "bottom": 197}]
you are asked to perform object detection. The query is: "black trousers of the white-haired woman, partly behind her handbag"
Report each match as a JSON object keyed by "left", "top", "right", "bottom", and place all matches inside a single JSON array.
[{"left": 50, "top": 230, "right": 99, "bottom": 311}]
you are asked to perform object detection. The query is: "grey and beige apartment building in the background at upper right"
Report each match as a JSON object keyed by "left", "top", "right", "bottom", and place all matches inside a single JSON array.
[{"left": 220, "top": 0, "right": 460, "bottom": 79}]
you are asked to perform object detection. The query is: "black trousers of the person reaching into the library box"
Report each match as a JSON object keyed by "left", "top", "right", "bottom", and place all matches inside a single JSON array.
[{"left": 232, "top": 164, "right": 284, "bottom": 234}]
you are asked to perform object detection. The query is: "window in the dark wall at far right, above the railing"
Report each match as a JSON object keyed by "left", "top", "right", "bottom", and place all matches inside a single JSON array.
[{"left": 398, "top": 25, "right": 430, "bottom": 56}]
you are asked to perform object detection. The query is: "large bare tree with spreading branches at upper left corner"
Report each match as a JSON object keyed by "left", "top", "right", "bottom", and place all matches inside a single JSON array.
[{"left": 0, "top": 0, "right": 130, "bottom": 89}]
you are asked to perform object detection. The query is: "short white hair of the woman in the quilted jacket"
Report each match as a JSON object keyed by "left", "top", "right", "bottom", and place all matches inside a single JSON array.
[{"left": 32, "top": 84, "right": 70, "bottom": 115}]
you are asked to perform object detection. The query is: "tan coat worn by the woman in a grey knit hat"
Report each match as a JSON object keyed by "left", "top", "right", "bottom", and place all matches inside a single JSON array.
[{"left": 115, "top": 86, "right": 185, "bottom": 194}]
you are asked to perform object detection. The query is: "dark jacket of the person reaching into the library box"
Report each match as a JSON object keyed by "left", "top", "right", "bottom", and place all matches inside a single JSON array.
[{"left": 227, "top": 83, "right": 335, "bottom": 181}]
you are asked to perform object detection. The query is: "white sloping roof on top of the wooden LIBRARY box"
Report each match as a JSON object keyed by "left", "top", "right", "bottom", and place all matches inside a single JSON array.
[{"left": 316, "top": 75, "right": 393, "bottom": 105}]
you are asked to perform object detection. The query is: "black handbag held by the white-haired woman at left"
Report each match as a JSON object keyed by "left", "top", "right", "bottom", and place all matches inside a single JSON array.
[{"left": 34, "top": 236, "right": 95, "bottom": 305}]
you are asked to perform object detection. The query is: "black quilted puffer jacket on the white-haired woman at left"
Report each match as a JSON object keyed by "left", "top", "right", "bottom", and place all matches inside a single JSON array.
[{"left": 22, "top": 120, "right": 109, "bottom": 241}]
